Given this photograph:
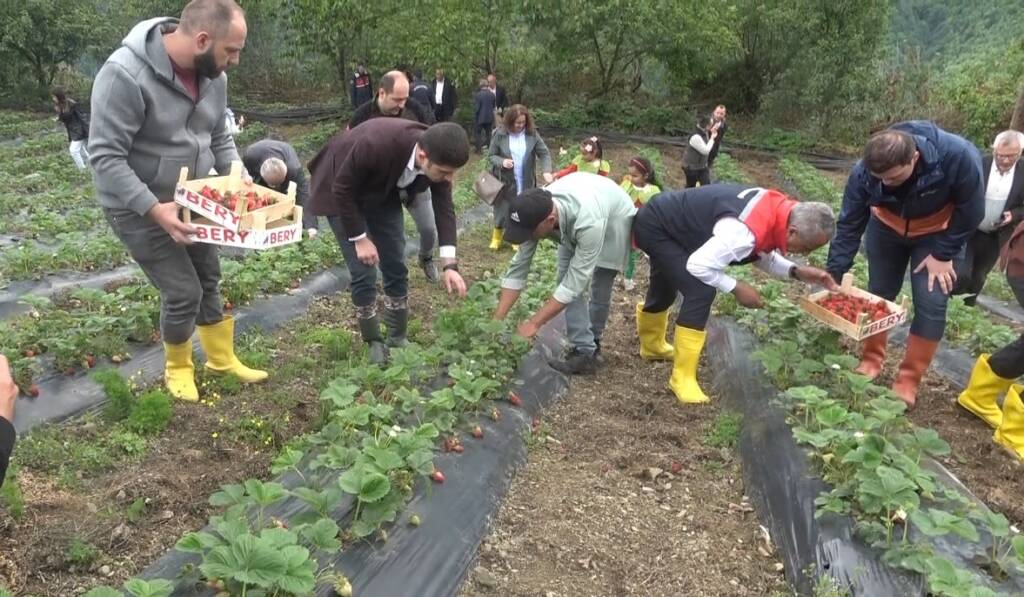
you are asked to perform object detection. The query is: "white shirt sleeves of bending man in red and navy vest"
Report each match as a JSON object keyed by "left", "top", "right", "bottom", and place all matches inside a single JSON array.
[{"left": 686, "top": 218, "right": 794, "bottom": 292}]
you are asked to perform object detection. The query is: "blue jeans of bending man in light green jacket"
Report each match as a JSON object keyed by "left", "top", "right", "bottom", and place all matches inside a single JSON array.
[{"left": 558, "top": 245, "right": 618, "bottom": 354}]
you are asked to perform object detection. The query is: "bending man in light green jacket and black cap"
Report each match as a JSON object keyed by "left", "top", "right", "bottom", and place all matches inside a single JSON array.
[{"left": 495, "top": 172, "right": 636, "bottom": 374}]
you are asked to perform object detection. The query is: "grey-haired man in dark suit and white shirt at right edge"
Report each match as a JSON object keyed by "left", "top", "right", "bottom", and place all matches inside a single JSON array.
[{"left": 953, "top": 130, "right": 1024, "bottom": 305}]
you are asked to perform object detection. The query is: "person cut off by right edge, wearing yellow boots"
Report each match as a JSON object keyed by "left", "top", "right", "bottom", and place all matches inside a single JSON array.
[{"left": 956, "top": 222, "right": 1024, "bottom": 461}]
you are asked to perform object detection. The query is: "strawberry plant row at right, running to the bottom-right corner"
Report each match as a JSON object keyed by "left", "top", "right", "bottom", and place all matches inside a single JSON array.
[{"left": 720, "top": 272, "right": 1024, "bottom": 597}]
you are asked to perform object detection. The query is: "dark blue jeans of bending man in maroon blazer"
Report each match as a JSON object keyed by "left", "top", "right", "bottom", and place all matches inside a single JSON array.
[{"left": 327, "top": 202, "right": 409, "bottom": 307}]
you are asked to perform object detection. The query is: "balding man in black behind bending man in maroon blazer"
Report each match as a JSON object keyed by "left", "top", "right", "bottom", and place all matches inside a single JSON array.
[{"left": 348, "top": 71, "right": 440, "bottom": 282}]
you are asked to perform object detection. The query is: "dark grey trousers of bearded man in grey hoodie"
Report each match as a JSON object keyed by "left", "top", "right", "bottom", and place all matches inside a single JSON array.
[{"left": 103, "top": 208, "right": 223, "bottom": 344}]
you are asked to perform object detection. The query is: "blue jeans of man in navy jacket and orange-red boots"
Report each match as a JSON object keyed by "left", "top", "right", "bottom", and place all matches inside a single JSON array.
[{"left": 864, "top": 217, "right": 964, "bottom": 341}]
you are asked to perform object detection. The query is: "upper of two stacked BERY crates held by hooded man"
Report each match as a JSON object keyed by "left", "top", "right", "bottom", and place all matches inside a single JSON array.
[{"left": 174, "top": 161, "right": 295, "bottom": 232}]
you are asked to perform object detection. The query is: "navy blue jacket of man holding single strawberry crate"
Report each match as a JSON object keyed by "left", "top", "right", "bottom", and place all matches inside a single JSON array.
[{"left": 825, "top": 120, "right": 985, "bottom": 278}]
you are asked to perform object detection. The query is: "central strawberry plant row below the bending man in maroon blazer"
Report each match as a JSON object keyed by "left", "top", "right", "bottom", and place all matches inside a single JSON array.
[{"left": 80, "top": 243, "right": 555, "bottom": 597}]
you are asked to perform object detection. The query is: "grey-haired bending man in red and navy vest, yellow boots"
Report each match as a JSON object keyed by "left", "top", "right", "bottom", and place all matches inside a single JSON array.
[{"left": 633, "top": 184, "right": 838, "bottom": 403}]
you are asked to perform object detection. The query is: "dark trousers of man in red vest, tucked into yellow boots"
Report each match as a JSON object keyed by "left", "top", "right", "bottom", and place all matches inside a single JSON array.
[{"left": 633, "top": 209, "right": 717, "bottom": 330}]
